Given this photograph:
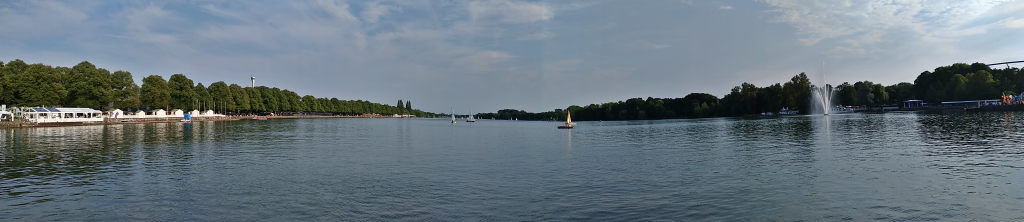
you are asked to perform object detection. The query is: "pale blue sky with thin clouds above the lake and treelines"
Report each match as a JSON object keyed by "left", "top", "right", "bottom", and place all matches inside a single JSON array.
[{"left": 0, "top": 0, "right": 1024, "bottom": 113}]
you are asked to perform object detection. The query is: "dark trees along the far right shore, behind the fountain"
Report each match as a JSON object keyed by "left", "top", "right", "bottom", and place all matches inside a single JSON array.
[{"left": 478, "top": 63, "right": 1024, "bottom": 121}]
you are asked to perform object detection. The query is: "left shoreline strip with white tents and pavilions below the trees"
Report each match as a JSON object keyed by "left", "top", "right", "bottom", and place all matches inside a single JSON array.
[{"left": 0, "top": 116, "right": 423, "bottom": 129}]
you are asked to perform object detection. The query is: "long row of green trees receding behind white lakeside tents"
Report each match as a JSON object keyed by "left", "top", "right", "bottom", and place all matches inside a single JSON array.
[{"left": 0, "top": 59, "right": 433, "bottom": 117}]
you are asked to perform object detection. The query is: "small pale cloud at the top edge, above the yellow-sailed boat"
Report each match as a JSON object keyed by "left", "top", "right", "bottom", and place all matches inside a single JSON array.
[{"left": 467, "top": 0, "right": 555, "bottom": 24}]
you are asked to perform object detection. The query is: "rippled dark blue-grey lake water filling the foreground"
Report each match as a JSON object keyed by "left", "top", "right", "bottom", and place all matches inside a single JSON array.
[{"left": 0, "top": 113, "right": 1024, "bottom": 221}]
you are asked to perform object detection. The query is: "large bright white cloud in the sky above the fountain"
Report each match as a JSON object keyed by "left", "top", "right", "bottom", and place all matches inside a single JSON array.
[{"left": 762, "top": 0, "right": 1004, "bottom": 48}]
